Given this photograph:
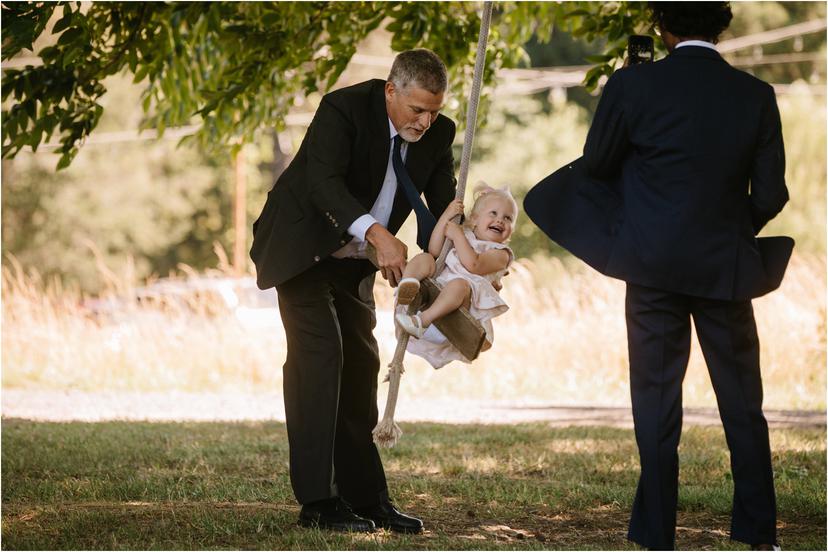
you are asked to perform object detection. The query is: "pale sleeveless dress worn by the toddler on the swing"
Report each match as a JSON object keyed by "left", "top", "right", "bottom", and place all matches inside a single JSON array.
[{"left": 407, "top": 230, "right": 514, "bottom": 368}]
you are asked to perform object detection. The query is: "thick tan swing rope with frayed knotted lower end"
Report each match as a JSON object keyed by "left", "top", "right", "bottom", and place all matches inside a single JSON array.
[{"left": 373, "top": 2, "right": 492, "bottom": 447}]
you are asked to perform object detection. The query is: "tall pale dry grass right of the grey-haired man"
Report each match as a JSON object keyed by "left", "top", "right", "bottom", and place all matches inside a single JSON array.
[{"left": 384, "top": 251, "right": 826, "bottom": 409}]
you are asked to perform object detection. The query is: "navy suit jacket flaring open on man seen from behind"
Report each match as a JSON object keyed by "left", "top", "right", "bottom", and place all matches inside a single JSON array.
[{"left": 525, "top": 46, "right": 793, "bottom": 300}]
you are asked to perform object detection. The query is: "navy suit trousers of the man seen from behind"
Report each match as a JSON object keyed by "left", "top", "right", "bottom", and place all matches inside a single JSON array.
[{"left": 626, "top": 284, "right": 776, "bottom": 550}]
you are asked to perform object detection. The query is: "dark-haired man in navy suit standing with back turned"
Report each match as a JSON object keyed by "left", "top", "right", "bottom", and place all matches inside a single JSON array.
[{"left": 525, "top": 2, "right": 793, "bottom": 549}]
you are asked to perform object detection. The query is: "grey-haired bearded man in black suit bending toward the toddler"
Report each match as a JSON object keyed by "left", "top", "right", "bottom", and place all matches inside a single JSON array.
[{"left": 250, "top": 49, "right": 456, "bottom": 533}]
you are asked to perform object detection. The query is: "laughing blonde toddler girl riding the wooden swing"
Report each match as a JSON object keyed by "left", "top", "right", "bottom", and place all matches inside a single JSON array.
[{"left": 396, "top": 186, "right": 517, "bottom": 368}]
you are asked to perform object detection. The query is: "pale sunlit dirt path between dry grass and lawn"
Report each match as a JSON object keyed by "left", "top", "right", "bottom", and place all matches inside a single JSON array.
[{"left": 2, "top": 389, "right": 826, "bottom": 428}]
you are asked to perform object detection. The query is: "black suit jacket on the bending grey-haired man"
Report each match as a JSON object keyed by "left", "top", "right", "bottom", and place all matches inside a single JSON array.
[{"left": 250, "top": 79, "right": 456, "bottom": 289}]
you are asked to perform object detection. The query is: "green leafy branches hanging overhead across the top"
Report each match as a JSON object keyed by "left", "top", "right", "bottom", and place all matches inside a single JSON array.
[{"left": 2, "top": 2, "right": 648, "bottom": 169}]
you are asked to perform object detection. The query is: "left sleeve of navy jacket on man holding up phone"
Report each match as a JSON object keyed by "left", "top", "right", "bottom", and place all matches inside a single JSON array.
[{"left": 583, "top": 69, "right": 630, "bottom": 178}]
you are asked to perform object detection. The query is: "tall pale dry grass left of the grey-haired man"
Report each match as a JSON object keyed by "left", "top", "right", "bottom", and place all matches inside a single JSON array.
[{"left": 2, "top": 254, "right": 285, "bottom": 391}]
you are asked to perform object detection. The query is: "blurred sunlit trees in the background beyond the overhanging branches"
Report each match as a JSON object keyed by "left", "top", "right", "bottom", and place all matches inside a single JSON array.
[{"left": 0, "top": 2, "right": 826, "bottom": 291}]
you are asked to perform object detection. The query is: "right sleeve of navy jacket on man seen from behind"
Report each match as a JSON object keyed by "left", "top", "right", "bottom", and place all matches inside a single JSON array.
[{"left": 750, "top": 85, "right": 788, "bottom": 234}]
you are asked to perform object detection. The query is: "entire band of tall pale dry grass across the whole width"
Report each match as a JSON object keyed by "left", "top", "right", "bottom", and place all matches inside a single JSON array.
[{"left": 2, "top": 250, "right": 826, "bottom": 409}]
